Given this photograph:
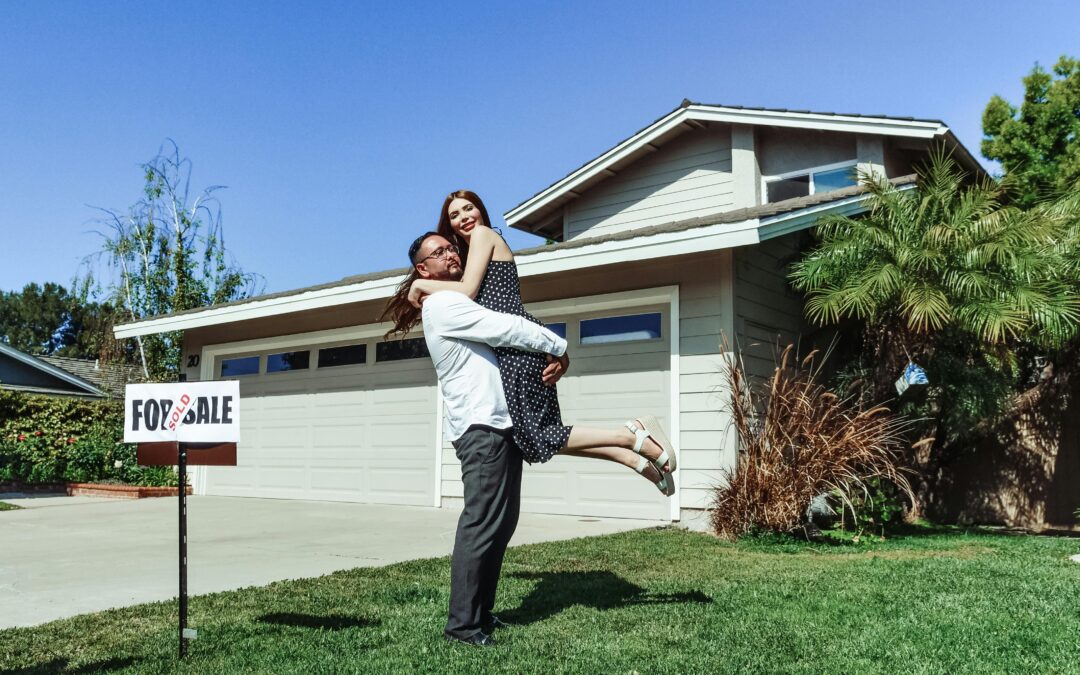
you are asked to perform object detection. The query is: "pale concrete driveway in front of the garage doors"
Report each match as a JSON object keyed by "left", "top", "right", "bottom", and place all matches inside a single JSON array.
[{"left": 0, "top": 495, "right": 660, "bottom": 629}]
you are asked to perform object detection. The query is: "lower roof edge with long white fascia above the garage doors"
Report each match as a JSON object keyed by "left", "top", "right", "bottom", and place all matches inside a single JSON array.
[{"left": 114, "top": 175, "right": 916, "bottom": 338}]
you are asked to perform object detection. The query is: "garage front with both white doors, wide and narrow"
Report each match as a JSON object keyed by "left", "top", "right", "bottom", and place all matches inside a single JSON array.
[{"left": 195, "top": 287, "right": 678, "bottom": 521}]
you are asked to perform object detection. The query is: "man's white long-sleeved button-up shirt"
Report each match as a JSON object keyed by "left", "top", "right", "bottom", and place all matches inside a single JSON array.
[{"left": 421, "top": 291, "right": 566, "bottom": 441}]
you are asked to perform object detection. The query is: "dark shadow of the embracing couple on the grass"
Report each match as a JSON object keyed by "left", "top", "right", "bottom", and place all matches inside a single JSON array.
[{"left": 499, "top": 571, "right": 713, "bottom": 625}]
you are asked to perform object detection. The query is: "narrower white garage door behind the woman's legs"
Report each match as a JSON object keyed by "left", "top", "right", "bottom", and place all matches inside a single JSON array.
[{"left": 522, "top": 306, "right": 672, "bottom": 521}]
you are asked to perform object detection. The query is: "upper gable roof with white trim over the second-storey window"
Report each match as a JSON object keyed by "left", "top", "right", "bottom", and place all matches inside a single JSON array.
[{"left": 503, "top": 99, "right": 983, "bottom": 233}]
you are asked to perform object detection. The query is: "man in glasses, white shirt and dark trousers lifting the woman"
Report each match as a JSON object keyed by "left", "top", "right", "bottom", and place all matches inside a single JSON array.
[{"left": 409, "top": 232, "right": 569, "bottom": 646}]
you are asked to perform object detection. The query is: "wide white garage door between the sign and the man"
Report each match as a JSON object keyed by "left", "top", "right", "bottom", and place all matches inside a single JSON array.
[{"left": 205, "top": 342, "right": 436, "bottom": 505}]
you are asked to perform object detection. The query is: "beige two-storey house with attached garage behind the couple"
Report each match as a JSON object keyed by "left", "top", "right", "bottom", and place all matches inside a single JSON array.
[{"left": 116, "top": 102, "right": 981, "bottom": 522}]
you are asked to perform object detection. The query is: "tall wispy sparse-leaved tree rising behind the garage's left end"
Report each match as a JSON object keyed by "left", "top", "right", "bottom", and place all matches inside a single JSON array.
[{"left": 84, "top": 141, "right": 257, "bottom": 380}]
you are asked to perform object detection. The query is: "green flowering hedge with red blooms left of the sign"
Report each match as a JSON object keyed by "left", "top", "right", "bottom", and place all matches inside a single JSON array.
[{"left": 0, "top": 391, "right": 177, "bottom": 486}]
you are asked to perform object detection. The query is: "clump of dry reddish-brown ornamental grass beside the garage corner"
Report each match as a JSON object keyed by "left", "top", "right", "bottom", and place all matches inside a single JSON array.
[{"left": 711, "top": 345, "right": 915, "bottom": 539}]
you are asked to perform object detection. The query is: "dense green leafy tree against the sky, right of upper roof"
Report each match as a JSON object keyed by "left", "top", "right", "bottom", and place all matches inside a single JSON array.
[{"left": 982, "top": 56, "right": 1080, "bottom": 206}]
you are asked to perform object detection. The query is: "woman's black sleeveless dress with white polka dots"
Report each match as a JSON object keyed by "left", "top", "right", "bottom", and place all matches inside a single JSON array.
[{"left": 476, "top": 260, "right": 570, "bottom": 464}]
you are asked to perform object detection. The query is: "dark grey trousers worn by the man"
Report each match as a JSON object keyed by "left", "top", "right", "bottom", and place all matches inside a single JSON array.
[{"left": 445, "top": 424, "right": 522, "bottom": 638}]
